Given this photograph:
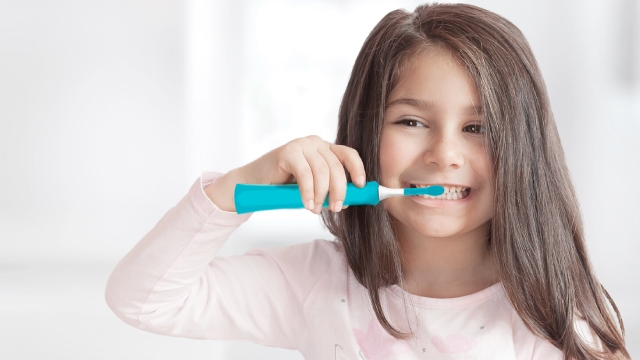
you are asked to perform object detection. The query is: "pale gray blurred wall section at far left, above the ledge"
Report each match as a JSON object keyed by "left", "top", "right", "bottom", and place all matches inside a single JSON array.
[{"left": 0, "top": 1, "right": 185, "bottom": 262}]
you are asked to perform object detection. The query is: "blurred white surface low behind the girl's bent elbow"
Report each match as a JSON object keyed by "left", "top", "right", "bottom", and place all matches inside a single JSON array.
[{"left": 0, "top": 263, "right": 640, "bottom": 360}]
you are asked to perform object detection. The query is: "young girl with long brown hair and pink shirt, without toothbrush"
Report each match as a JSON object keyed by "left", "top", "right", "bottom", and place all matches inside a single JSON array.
[{"left": 106, "top": 4, "right": 629, "bottom": 360}]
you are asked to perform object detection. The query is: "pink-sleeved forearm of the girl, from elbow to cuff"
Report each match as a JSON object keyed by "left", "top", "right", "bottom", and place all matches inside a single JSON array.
[{"left": 105, "top": 173, "right": 248, "bottom": 331}]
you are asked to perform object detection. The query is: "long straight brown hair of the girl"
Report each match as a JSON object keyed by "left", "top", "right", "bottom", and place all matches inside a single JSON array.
[{"left": 322, "top": 4, "right": 629, "bottom": 359}]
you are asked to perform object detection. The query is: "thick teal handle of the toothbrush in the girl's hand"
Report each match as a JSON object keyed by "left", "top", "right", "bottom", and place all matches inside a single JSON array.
[{"left": 233, "top": 181, "right": 380, "bottom": 214}]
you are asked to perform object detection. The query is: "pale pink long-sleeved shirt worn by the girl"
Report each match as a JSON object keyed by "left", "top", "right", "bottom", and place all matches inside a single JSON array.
[{"left": 106, "top": 173, "right": 562, "bottom": 360}]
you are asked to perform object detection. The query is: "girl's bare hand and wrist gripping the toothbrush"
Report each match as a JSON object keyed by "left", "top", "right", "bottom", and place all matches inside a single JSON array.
[{"left": 205, "top": 135, "right": 366, "bottom": 214}]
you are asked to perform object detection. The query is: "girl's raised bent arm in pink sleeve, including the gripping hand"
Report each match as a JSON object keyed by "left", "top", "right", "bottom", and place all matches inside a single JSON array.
[{"left": 106, "top": 136, "right": 366, "bottom": 348}]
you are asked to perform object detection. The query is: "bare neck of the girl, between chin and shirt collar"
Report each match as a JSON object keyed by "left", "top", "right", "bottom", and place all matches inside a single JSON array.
[{"left": 396, "top": 223, "right": 498, "bottom": 298}]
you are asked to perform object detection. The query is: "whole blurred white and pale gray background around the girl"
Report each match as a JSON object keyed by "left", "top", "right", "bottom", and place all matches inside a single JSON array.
[{"left": 0, "top": 0, "right": 640, "bottom": 359}]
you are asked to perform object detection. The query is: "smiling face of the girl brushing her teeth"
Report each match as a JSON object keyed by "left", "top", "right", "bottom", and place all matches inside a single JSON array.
[{"left": 380, "top": 47, "right": 493, "bottom": 238}]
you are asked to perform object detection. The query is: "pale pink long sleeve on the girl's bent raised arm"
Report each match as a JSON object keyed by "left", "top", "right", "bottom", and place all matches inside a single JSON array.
[{"left": 105, "top": 173, "right": 330, "bottom": 349}]
